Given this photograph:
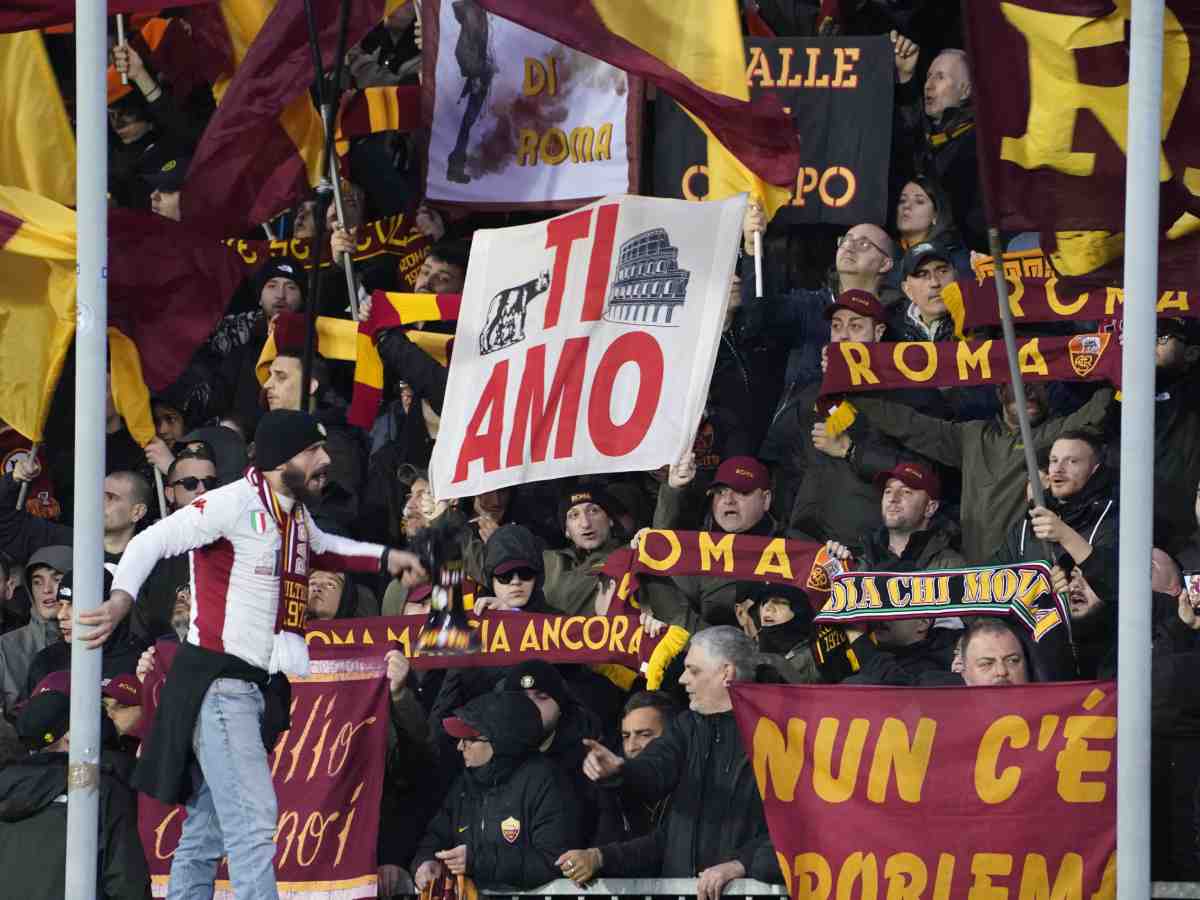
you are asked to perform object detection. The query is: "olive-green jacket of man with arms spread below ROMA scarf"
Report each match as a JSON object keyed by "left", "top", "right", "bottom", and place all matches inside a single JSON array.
[{"left": 854, "top": 384, "right": 1112, "bottom": 565}]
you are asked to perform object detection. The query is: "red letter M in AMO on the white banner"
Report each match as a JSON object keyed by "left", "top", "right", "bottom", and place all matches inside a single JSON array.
[{"left": 505, "top": 337, "right": 588, "bottom": 466}]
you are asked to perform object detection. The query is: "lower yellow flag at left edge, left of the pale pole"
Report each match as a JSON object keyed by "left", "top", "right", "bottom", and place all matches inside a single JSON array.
[{"left": 0, "top": 186, "right": 76, "bottom": 440}]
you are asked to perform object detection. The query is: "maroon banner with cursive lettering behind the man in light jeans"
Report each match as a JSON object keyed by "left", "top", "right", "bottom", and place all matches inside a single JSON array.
[{"left": 138, "top": 642, "right": 390, "bottom": 900}]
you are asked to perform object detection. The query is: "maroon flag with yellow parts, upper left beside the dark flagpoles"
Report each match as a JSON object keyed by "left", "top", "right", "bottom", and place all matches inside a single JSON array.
[{"left": 181, "top": 0, "right": 400, "bottom": 238}]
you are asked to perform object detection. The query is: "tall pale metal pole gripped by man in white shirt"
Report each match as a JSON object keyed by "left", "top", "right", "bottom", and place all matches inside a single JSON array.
[{"left": 65, "top": 0, "right": 108, "bottom": 900}]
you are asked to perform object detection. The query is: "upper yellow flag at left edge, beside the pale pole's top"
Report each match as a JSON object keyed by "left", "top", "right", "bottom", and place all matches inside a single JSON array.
[{"left": 0, "top": 31, "right": 76, "bottom": 206}]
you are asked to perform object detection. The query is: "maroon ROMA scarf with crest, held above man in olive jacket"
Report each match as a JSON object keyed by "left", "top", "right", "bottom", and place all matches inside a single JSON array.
[{"left": 821, "top": 331, "right": 1121, "bottom": 396}]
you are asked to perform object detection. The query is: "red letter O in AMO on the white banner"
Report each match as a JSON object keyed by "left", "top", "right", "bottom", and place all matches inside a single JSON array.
[{"left": 588, "top": 331, "right": 664, "bottom": 456}]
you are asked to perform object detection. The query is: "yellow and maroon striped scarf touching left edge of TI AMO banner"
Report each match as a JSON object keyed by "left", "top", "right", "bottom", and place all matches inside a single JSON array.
[{"left": 346, "top": 290, "right": 462, "bottom": 428}]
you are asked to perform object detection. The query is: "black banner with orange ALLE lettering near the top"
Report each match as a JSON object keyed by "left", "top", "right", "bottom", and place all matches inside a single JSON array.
[{"left": 654, "top": 37, "right": 894, "bottom": 226}]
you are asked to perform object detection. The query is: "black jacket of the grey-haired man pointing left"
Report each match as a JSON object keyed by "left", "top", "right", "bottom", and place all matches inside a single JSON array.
[{"left": 601, "top": 710, "right": 782, "bottom": 883}]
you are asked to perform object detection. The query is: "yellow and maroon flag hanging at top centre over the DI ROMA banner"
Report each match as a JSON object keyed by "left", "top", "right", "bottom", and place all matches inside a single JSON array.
[{"left": 478, "top": 0, "right": 800, "bottom": 205}]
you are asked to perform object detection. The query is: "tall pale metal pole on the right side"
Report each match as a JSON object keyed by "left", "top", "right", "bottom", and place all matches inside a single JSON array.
[{"left": 1117, "top": 0, "right": 1163, "bottom": 900}]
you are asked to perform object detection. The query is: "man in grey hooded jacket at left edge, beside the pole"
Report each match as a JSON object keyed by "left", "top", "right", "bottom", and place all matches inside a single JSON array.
[{"left": 0, "top": 545, "right": 71, "bottom": 716}]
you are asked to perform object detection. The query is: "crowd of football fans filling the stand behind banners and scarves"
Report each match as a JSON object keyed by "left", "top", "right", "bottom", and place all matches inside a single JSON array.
[{"left": 0, "top": 0, "right": 1200, "bottom": 898}]
